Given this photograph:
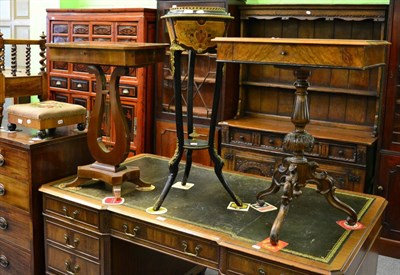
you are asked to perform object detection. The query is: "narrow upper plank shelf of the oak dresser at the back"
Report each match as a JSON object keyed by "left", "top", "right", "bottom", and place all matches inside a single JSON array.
[{"left": 241, "top": 81, "right": 378, "bottom": 97}]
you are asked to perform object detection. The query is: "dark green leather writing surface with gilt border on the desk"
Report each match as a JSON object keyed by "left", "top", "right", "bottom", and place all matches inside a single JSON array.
[{"left": 47, "top": 154, "right": 382, "bottom": 263}]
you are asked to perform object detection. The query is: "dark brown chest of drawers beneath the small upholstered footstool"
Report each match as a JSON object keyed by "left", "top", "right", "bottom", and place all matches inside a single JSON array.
[{"left": 0, "top": 126, "right": 93, "bottom": 275}]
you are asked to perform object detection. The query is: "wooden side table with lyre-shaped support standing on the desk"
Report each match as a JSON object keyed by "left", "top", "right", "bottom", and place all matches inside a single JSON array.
[{"left": 47, "top": 41, "right": 167, "bottom": 198}]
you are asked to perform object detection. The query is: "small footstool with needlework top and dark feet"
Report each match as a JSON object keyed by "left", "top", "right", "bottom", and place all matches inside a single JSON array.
[{"left": 7, "top": 100, "right": 86, "bottom": 138}]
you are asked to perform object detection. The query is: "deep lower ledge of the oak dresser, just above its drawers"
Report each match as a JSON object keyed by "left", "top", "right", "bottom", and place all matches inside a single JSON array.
[{"left": 219, "top": 115, "right": 377, "bottom": 146}]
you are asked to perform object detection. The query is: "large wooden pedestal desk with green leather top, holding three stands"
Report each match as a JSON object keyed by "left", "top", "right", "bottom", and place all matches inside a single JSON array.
[{"left": 40, "top": 154, "right": 386, "bottom": 275}]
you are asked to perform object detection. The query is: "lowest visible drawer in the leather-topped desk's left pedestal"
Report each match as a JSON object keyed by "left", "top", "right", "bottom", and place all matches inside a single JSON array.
[{"left": 46, "top": 243, "right": 103, "bottom": 275}]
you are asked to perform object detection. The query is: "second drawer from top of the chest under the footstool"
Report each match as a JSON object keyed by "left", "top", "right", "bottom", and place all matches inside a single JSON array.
[{"left": 0, "top": 175, "right": 30, "bottom": 211}]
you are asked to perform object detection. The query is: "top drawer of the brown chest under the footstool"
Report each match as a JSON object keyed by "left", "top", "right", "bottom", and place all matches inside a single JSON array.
[{"left": 0, "top": 144, "right": 29, "bottom": 181}]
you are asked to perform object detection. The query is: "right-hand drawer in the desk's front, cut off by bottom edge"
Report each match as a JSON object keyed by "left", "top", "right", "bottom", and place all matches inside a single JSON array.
[{"left": 226, "top": 251, "right": 308, "bottom": 275}]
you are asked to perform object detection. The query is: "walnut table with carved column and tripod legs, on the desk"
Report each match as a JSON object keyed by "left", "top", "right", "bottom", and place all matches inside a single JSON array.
[{"left": 213, "top": 37, "right": 389, "bottom": 245}]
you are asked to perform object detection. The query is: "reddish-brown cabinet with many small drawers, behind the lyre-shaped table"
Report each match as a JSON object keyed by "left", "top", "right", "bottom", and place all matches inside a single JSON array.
[{"left": 47, "top": 8, "right": 156, "bottom": 154}]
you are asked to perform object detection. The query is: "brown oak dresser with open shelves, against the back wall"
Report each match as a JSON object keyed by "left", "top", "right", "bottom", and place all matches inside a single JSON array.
[{"left": 220, "top": 5, "right": 387, "bottom": 192}]
